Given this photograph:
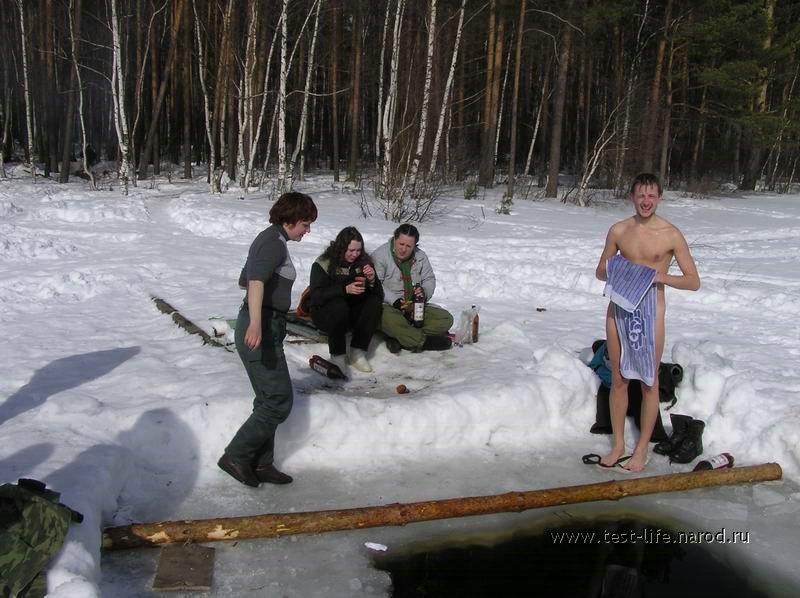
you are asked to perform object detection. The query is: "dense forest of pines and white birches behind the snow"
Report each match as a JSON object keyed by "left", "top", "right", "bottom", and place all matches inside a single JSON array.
[{"left": 0, "top": 0, "right": 800, "bottom": 206}]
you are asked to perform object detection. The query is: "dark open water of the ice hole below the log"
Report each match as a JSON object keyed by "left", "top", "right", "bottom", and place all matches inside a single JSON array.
[{"left": 375, "top": 519, "right": 780, "bottom": 598}]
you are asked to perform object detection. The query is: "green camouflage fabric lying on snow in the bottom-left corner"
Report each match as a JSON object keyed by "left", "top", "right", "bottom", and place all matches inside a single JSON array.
[{"left": 0, "top": 480, "right": 83, "bottom": 598}]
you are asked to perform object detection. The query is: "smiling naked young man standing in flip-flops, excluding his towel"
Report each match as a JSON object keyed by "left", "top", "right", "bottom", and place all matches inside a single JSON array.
[{"left": 595, "top": 173, "right": 700, "bottom": 471}]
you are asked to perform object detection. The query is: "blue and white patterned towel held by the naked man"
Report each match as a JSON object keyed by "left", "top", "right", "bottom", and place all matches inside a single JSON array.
[{"left": 603, "top": 255, "right": 658, "bottom": 386}]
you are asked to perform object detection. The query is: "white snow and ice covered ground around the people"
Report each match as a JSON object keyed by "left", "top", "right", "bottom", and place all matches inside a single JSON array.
[{"left": 0, "top": 168, "right": 800, "bottom": 597}]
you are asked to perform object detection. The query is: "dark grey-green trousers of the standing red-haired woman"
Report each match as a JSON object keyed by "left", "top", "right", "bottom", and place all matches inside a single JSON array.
[{"left": 225, "top": 307, "right": 293, "bottom": 467}]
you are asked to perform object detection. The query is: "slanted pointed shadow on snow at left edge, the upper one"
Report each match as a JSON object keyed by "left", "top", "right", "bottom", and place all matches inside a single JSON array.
[{"left": 0, "top": 347, "right": 141, "bottom": 425}]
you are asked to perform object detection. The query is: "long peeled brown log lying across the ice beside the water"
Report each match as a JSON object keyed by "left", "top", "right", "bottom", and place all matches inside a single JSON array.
[{"left": 103, "top": 463, "right": 782, "bottom": 550}]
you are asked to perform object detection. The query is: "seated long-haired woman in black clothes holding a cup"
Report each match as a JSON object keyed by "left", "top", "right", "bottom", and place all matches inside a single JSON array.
[{"left": 307, "top": 226, "right": 383, "bottom": 372}]
